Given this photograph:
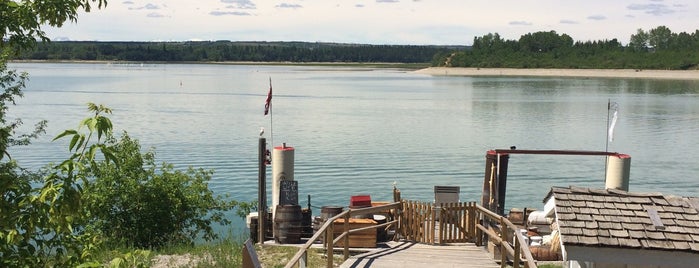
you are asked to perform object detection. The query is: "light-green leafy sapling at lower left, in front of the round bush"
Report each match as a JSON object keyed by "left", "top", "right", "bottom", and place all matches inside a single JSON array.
[{"left": 0, "top": 102, "right": 114, "bottom": 267}]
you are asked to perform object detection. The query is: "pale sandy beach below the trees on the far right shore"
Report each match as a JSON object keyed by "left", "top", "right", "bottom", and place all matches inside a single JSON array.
[{"left": 415, "top": 67, "right": 699, "bottom": 80}]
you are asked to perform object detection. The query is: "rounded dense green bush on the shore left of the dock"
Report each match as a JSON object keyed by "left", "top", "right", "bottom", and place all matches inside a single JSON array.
[{"left": 85, "top": 133, "right": 236, "bottom": 248}]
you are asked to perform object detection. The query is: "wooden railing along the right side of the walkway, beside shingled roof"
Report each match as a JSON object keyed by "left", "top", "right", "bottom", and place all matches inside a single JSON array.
[{"left": 473, "top": 205, "right": 536, "bottom": 268}]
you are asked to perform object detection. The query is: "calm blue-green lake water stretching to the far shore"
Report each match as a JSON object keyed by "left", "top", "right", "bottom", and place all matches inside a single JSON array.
[{"left": 10, "top": 64, "right": 699, "bottom": 232}]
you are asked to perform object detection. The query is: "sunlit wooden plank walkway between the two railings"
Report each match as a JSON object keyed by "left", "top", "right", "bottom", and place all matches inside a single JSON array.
[{"left": 340, "top": 241, "right": 500, "bottom": 268}]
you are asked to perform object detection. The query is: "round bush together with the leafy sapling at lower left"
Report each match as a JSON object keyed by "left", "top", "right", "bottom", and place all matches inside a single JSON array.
[{"left": 0, "top": 98, "right": 235, "bottom": 267}]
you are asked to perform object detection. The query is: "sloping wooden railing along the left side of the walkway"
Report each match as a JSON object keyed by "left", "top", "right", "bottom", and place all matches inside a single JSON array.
[{"left": 284, "top": 202, "right": 402, "bottom": 268}]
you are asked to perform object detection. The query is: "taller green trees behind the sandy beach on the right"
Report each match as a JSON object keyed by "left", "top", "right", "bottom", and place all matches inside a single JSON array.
[{"left": 442, "top": 26, "right": 699, "bottom": 70}]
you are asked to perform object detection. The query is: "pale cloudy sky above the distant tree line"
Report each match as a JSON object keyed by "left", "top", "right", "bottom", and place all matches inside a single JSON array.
[{"left": 44, "top": 0, "right": 699, "bottom": 45}]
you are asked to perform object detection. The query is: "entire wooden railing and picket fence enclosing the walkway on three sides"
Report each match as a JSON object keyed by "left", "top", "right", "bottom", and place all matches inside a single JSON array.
[{"left": 285, "top": 201, "right": 536, "bottom": 268}]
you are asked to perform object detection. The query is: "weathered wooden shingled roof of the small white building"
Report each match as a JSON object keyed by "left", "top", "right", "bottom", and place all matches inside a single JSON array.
[{"left": 545, "top": 187, "right": 699, "bottom": 253}]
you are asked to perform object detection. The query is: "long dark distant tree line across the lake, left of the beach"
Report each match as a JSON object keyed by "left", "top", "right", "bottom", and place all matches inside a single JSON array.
[{"left": 17, "top": 41, "right": 465, "bottom": 63}]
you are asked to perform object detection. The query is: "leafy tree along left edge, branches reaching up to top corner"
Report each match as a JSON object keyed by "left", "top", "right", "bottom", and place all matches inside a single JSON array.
[{"left": 0, "top": 0, "right": 106, "bottom": 267}]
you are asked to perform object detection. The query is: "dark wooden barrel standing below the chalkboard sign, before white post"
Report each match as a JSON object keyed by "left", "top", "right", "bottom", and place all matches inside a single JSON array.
[{"left": 274, "top": 205, "right": 302, "bottom": 244}]
